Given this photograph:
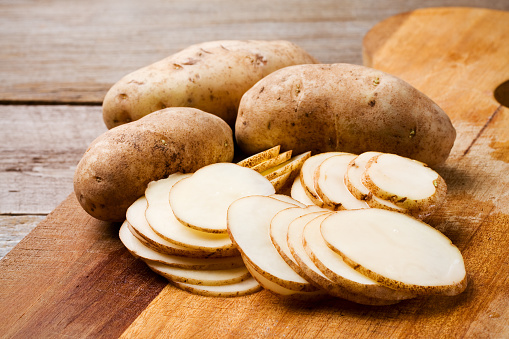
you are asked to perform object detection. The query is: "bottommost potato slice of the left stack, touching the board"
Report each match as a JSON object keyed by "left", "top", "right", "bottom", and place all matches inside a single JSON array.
[{"left": 172, "top": 277, "right": 262, "bottom": 298}]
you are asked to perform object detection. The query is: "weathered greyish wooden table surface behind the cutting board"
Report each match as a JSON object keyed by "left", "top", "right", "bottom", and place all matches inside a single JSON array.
[{"left": 0, "top": 0, "right": 509, "bottom": 258}]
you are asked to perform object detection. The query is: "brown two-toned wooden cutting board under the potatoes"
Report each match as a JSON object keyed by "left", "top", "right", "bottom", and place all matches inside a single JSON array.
[{"left": 0, "top": 8, "right": 509, "bottom": 338}]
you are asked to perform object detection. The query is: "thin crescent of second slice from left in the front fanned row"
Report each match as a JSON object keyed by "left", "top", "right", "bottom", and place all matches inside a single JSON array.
[{"left": 269, "top": 206, "right": 323, "bottom": 273}]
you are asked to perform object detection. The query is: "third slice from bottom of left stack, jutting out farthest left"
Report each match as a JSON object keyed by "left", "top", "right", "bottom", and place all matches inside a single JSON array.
[{"left": 119, "top": 221, "right": 244, "bottom": 270}]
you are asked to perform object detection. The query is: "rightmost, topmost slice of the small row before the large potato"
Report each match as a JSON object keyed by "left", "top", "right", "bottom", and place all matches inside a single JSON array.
[{"left": 361, "top": 153, "right": 447, "bottom": 211}]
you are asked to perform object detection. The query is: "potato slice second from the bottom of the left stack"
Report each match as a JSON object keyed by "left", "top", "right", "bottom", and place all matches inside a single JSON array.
[{"left": 146, "top": 261, "right": 251, "bottom": 286}]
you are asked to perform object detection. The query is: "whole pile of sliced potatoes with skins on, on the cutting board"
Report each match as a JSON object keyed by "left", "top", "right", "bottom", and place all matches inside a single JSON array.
[{"left": 120, "top": 147, "right": 467, "bottom": 305}]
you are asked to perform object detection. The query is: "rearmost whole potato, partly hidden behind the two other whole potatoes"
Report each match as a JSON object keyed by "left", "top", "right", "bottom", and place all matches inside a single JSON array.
[{"left": 103, "top": 40, "right": 317, "bottom": 128}]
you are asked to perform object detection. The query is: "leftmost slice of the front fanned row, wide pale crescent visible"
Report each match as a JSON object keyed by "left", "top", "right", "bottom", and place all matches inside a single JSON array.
[{"left": 228, "top": 195, "right": 316, "bottom": 291}]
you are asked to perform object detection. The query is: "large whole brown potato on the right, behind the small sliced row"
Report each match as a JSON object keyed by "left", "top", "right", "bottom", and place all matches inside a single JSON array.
[{"left": 235, "top": 64, "right": 456, "bottom": 166}]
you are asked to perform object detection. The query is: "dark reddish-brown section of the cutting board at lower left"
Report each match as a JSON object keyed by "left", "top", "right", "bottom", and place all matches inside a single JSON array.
[{"left": 0, "top": 195, "right": 166, "bottom": 338}]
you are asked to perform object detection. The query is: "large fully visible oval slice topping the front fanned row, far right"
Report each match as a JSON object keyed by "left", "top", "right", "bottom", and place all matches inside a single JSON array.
[{"left": 321, "top": 208, "right": 467, "bottom": 295}]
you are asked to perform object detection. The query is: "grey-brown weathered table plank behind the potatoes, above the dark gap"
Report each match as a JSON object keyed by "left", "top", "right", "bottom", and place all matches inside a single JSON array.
[{"left": 0, "top": 0, "right": 509, "bottom": 104}]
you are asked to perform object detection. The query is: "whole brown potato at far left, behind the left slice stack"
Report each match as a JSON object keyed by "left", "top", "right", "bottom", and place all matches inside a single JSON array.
[{"left": 74, "top": 108, "right": 234, "bottom": 222}]
